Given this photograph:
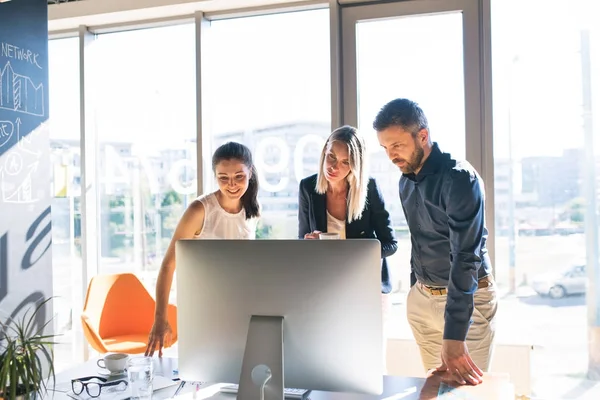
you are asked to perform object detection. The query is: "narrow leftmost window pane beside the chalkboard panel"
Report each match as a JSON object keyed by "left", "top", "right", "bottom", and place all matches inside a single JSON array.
[{"left": 48, "top": 38, "right": 83, "bottom": 371}]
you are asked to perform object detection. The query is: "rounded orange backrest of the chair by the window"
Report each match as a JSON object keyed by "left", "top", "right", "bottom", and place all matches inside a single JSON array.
[{"left": 83, "top": 273, "right": 155, "bottom": 338}]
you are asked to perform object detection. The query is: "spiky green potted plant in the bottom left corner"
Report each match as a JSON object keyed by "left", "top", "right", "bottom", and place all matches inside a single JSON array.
[{"left": 0, "top": 299, "right": 55, "bottom": 400}]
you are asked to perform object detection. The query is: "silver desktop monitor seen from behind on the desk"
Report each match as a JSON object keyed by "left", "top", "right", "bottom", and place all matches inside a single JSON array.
[{"left": 176, "top": 239, "right": 384, "bottom": 400}]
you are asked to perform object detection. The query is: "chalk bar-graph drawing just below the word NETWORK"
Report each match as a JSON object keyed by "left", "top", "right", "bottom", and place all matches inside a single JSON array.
[{"left": 0, "top": 61, "right": 44, "bottom": 116}]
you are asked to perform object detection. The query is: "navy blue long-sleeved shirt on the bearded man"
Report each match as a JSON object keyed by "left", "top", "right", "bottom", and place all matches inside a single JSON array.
[{"left": 400, "top": 143, "right": 492, "bottom": 340}]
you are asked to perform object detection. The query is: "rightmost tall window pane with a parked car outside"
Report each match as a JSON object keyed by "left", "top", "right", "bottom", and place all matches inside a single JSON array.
[{"left": 492, "top": 0, "right": 600, "bottom": 398}]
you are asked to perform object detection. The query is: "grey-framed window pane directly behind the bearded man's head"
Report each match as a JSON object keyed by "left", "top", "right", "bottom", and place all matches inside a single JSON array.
[{"left": 344, "top": 7, "right": 466, "bottom": 316}]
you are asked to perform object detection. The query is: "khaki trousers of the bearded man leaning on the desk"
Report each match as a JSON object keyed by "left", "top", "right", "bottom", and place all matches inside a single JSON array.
[{"left": 406, "top": 282, "right": 498, "bottom": 371}]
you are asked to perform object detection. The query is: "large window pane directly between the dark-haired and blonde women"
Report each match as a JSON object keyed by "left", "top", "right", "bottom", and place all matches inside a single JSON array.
[{"left": 203, "top": 10, "right": 331, "bottom": 238}]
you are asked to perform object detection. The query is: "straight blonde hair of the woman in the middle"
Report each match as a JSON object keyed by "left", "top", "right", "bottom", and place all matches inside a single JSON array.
[{"left": 315, "top": 125, "right": 368, "bottom": 222}]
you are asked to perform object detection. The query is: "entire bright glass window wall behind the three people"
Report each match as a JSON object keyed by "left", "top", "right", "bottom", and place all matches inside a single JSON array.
[{"left": 50, "top": 0, "right": 600, "bottom": 398}]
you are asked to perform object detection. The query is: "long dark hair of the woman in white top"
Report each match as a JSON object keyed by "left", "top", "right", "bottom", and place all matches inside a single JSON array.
[{"left": 212, "top": 142, "right": 260, "bottom": 219}]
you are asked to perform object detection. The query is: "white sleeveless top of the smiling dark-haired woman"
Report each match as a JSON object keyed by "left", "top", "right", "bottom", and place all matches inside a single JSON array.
[{"left": 194, "top": 193, "right": 257, "bottom": 239}]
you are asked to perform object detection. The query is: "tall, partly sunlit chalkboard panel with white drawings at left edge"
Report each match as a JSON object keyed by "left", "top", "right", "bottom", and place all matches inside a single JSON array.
[{"left": 0, "top": 0, "right": 52, "bottom": 338}]
